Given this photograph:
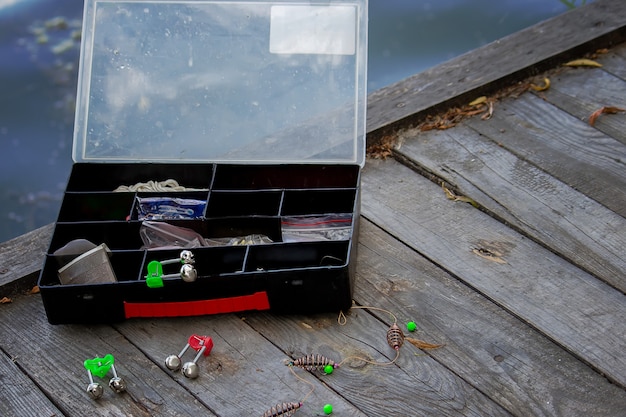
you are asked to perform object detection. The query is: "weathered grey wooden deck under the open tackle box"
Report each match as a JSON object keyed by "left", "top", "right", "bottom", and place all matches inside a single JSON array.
[{"left": 0, "top": 0, "right": 626, "bottom": 417}]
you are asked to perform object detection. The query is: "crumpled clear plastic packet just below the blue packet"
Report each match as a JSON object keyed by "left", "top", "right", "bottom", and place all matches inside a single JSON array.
[{"left": 139, "top": 221, "right": 206, "bottom": 249}]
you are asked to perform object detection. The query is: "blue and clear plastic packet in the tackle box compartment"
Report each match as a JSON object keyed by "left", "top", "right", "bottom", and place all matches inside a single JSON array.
[{"left": 137, "top": 197, "right": 206, "bottom": 220}]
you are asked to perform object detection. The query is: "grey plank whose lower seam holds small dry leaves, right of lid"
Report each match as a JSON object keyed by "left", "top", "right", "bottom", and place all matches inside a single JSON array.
[{"left": 398, "top": 122, "right": 626, "bottom": 292}]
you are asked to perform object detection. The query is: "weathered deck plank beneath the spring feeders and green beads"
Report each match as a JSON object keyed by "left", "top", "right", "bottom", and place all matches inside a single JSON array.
[{"left": 241, "top": 310, "right": 509, "bottom": 416}]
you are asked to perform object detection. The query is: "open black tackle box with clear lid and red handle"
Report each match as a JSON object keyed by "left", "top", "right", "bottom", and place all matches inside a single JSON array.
[{"left": 39, "top": 0, "right": 367, "bottom": 324}]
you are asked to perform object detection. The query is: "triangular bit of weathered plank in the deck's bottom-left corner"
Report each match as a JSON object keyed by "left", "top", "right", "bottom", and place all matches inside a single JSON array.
[{"left": 0, "top": 355, "right": 62, "bottom": 417}]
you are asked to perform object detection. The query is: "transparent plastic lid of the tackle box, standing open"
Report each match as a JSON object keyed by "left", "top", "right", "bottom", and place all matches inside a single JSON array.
[{"left": 73, "top": 0, "right": 367, "bottom": 165}]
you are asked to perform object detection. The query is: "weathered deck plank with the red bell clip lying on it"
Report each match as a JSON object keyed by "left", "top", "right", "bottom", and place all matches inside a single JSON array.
[{"left": 116, "top": 315, "right": 364, "bottom": 417}]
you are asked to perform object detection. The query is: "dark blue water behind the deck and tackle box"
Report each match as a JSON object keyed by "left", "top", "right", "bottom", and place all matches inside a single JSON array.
[{"left": 0, "top": 0, "right": 585, "bottom": 242}]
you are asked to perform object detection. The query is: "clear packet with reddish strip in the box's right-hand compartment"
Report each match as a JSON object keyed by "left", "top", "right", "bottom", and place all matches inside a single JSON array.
[{"left": 281, "top": 213, "right": 352, "bottom": 242}]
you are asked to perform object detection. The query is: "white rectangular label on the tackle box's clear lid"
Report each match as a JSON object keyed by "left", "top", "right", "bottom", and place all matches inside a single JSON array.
[{"left": 270, "top": 5, "right": 357, "bottom": 55}]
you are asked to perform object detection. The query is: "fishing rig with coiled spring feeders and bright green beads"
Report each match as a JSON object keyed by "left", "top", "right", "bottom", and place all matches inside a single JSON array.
[{"left": 261, "top": 305, "right": 442, "bottom": 417}]
